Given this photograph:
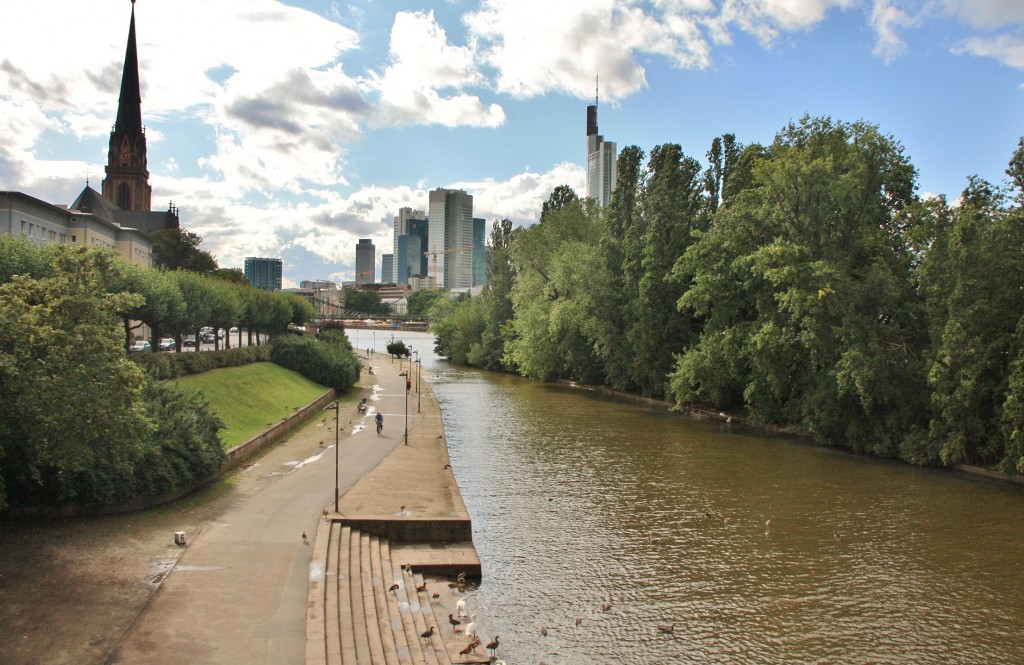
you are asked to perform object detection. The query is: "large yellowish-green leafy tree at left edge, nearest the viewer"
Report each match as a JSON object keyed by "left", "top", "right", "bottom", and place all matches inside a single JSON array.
[{"left": 0, "top": 246, "right": 151, "bottom": 507}]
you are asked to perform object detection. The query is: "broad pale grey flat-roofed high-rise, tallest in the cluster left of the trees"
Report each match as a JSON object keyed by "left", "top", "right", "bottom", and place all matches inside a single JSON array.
[{"left": 427, "top": 188, "right": 473, "bottom": 289}]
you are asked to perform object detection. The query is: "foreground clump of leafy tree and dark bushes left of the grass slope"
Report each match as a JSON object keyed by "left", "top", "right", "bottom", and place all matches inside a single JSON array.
[{"left": 0, "top": 236, "right": 223, "bottom": 510}]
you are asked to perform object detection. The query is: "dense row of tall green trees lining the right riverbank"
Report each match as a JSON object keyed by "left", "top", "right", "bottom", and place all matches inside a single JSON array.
[{"left": 432, "top": 118, "right": 1024, "bottom": 472}]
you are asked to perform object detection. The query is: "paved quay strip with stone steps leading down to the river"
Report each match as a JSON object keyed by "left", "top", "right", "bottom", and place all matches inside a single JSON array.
[{"left": 306, "top": 354, "right": 489, "bottom": 665}]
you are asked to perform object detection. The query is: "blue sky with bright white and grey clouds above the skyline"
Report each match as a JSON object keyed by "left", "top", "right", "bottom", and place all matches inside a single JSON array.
[{"left": 0, "top": 0, "right": 1024, "bottom": 287}]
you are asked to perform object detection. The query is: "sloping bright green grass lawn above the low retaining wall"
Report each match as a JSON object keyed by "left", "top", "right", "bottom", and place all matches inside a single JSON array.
[{"left": 178, "top": 363, "right": 328, "bottom": 450}]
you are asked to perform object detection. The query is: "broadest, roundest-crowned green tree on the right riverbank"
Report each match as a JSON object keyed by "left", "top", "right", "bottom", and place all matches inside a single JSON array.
[{"left": 672, "top": 118, "right": 926, "bottom": 455}]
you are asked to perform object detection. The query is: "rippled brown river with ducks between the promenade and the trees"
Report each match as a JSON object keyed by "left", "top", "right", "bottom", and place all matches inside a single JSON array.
[{"left": 349, "top": 331, "right": 1024, "bottom": 665}]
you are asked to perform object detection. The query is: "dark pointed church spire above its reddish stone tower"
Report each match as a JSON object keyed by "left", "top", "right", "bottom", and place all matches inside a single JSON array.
[{"left": 102, "top": 0, "right": 153, "bottom": 212}]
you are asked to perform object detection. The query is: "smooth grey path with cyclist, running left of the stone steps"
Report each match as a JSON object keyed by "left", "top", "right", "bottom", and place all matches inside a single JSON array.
[{"left": 108, "top": 355, "right": 404, "bottom": 665}]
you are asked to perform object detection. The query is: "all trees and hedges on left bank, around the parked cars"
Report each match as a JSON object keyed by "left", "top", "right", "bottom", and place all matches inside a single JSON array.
[{"left": 0, "top": 236, "right": 346, "bottom": 511}]
